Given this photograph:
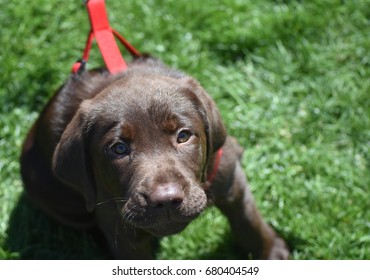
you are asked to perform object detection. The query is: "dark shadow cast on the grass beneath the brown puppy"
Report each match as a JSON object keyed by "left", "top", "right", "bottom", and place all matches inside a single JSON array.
[{"left": 5, "top": 194, "right": 246, "bottom": 260}]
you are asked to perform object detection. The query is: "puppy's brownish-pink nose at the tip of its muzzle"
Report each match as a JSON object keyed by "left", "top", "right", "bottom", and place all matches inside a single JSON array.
[{"left": 147, "top": 183, "right": 185, "bottom": 208}]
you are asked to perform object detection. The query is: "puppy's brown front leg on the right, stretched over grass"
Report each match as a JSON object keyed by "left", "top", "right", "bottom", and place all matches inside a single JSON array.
[{"left": 215, "top": 143, "right": 289, "bottom": 259}]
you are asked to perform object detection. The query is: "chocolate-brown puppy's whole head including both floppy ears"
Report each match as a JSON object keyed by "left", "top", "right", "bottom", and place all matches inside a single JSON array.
[{"left": 53, "top": 74, "right": 225, "bottom": 236}]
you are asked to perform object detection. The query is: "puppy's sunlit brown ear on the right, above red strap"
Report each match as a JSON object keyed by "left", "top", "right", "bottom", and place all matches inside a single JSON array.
[{"left": 183, "top": 78, "right": 226, "bottom": 155}]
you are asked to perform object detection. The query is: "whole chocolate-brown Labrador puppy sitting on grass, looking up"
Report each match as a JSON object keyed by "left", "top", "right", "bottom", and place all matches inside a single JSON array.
[{"left": 21, "top": 58, "right": 289, "bottom": 259}]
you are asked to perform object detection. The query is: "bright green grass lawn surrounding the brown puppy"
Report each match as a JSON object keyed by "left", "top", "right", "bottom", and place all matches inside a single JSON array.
[{"left": 0, "top": 0, "right": 370, "bottom": 259}]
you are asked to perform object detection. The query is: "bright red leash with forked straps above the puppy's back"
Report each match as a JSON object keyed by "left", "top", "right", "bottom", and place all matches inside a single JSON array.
[{"left": 72, "top": 0, "right": 141, "bottom": 74}]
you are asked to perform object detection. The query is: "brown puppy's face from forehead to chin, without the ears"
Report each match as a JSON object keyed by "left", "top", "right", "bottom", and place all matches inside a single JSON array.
[{"left": 88, "top": 77, "right": 207, "bottom": 235}]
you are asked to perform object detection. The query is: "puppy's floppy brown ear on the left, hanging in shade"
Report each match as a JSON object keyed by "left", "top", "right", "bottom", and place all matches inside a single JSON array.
[{"left": 53, "top": 105, "right": 96, "bottom": 212}]
